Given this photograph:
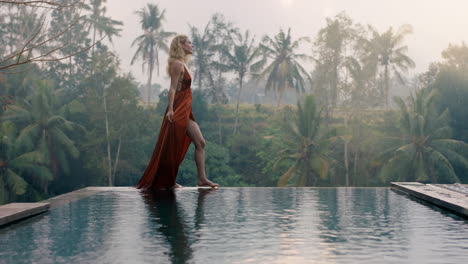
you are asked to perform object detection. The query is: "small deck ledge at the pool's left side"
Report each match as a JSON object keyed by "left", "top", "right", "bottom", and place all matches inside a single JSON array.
[{"left": 0, "top": 203, "right": 50, "bottom": 227}]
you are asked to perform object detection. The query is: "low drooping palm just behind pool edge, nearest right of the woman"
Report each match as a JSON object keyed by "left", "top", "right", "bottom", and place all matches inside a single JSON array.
[{"left": 275, "top": 95, "right": 332, "bottom": 186}]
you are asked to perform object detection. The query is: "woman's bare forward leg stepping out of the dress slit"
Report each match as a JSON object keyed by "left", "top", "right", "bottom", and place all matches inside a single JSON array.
[{"left": 187, "top": 119, "right": 219, "bottom": 187}]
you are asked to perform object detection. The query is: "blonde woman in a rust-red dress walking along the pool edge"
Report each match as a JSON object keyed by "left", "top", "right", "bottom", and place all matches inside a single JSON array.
[{"left": 136, "top": 35, "right": 219, "bottom": 190}]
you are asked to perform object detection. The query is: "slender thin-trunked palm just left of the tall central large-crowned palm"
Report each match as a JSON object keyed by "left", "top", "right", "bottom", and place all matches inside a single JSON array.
[{"left": 219, "top": 31, "right": 265, "bottom": 134}]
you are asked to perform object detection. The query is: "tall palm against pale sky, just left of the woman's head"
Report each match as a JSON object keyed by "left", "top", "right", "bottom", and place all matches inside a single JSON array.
[{"left": 130, "top": 4, "right": 175, "bottom": 104}]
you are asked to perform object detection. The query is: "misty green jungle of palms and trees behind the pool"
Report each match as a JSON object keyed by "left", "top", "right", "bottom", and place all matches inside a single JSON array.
[{"left": 0, "top": 0, "right": 468, "bottom": 204}]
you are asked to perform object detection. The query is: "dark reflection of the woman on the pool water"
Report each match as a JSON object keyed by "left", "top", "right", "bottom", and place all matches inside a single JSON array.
[{"left": 142, "top": 189, "right": 216, "bottom": 263}]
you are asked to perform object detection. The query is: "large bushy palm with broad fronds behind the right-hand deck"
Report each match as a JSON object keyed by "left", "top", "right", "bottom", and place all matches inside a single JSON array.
[{"left": 381, "top": 89, "right": 468, "bottom": 183}]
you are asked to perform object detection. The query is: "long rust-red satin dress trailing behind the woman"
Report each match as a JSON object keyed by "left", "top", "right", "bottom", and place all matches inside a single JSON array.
[{"left": 136, "top": 66, "right": 195, "bottom": 190}]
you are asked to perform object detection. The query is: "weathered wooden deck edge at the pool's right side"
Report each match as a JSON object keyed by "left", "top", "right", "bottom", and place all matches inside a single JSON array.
[{"left": 391, "top": 182, "right": 468, "bottom": 218}]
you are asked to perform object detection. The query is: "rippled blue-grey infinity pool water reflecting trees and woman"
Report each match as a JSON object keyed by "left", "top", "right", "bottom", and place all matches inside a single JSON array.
[{"left": 0, "top": 188, "right": 468, "bottom": 264}]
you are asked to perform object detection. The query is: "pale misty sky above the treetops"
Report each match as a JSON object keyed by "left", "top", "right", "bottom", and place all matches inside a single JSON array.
[{"left": 107, "top": 0, "right": 468, "bottom": 88}]
